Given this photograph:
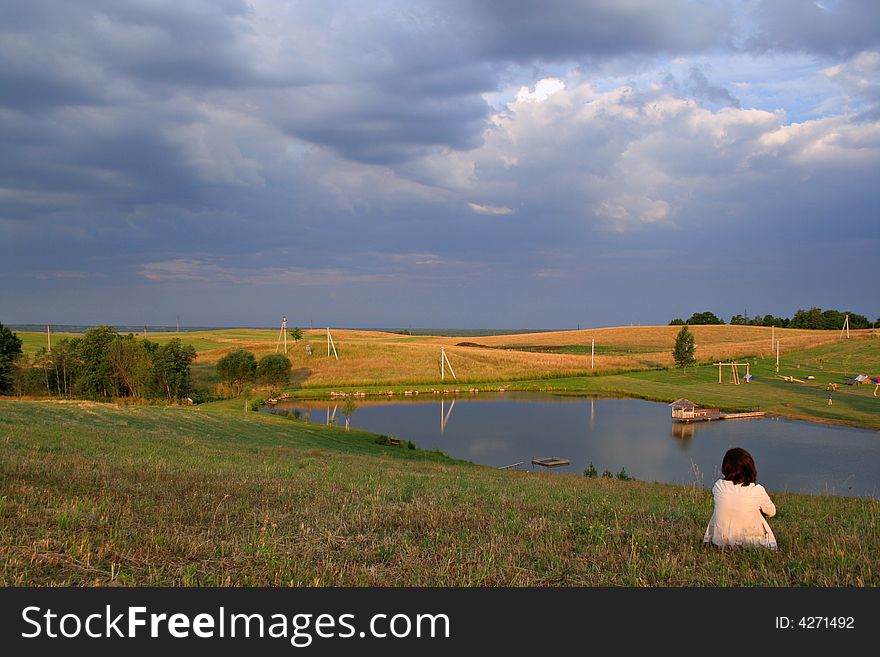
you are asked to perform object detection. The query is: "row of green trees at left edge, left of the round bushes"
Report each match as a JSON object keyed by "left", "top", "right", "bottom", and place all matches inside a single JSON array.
[{"left": 0, "top": 324, "right": 196, "bottom": 402}]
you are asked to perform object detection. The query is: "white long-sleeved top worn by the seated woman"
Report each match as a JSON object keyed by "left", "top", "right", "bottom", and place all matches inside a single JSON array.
[{"left": 703, "top": 479, "right": 776, "bottom": 550}]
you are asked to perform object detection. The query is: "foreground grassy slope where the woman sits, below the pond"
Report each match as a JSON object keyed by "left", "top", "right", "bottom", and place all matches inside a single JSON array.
[{"left": 0, "top": 401, "right": 880, "bottom": 586}]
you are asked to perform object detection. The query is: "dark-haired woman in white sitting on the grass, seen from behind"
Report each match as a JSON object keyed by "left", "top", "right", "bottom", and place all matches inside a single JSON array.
[{"left": 703, "top": 447, "right": 776, "bottom": 550}]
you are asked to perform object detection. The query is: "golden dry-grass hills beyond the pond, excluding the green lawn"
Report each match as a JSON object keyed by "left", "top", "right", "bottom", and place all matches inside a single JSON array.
[{"left": 19, "top": 326, "right": 870, "bottom": 388}]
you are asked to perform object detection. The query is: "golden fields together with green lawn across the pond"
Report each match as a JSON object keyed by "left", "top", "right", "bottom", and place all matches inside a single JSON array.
[{"left": 10, "top": 326, "right": 880, "bottom": 428}]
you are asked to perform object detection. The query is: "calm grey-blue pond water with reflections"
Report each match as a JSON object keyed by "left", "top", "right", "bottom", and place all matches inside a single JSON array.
[{"left": 275, "top": 392, "right": 880, "bottom": 497}]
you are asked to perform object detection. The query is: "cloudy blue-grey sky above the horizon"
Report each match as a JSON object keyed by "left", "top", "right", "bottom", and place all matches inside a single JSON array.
[{"left": 0, "top": 0, "right": 880, "bottom": 328}]
